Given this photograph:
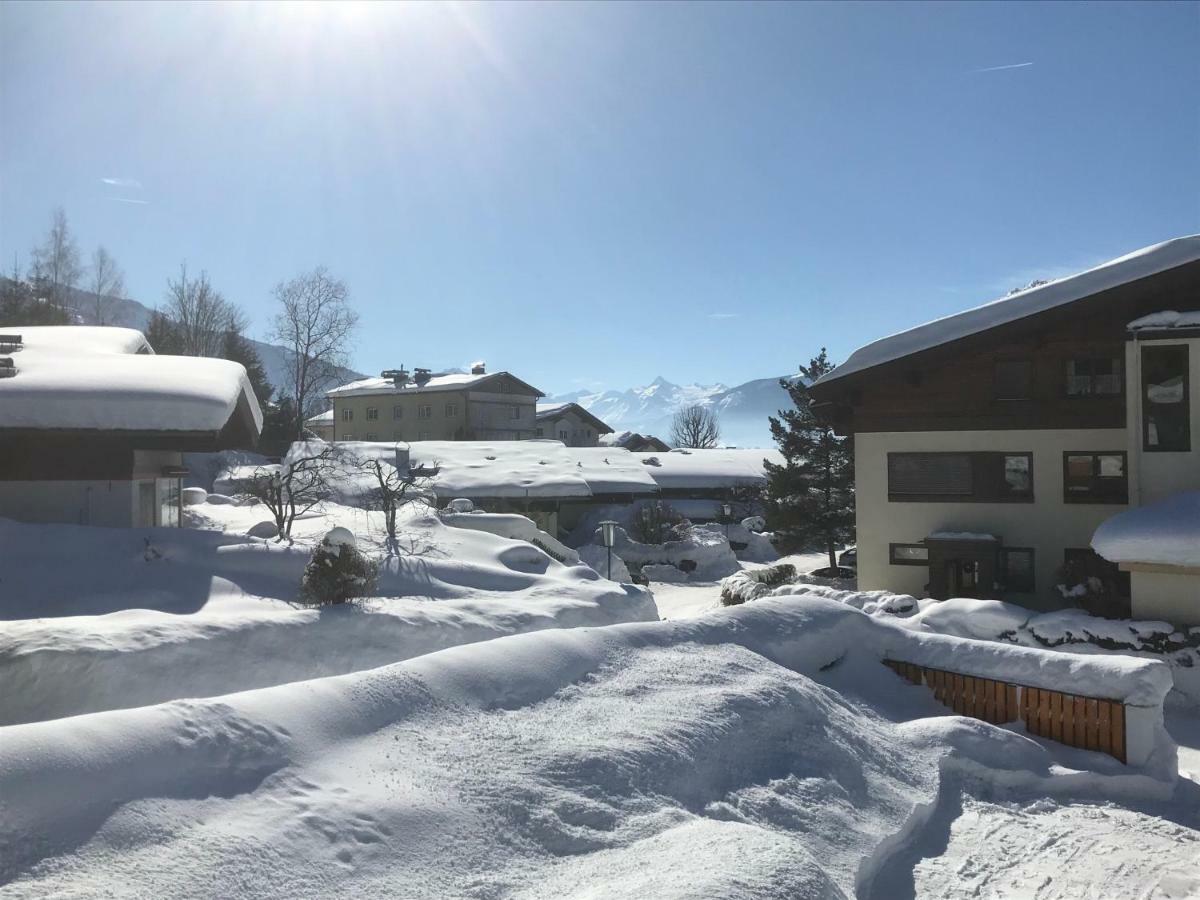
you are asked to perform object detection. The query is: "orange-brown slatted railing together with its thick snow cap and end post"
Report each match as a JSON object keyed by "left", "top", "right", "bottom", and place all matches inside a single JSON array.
[{"left": 883, "top": 634, "right": 1172, "bottom": 766}]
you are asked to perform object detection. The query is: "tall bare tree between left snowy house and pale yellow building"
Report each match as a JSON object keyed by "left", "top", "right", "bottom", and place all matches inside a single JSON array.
[{"left": 271, "top": 266, "right": 359, "bottom": 439}]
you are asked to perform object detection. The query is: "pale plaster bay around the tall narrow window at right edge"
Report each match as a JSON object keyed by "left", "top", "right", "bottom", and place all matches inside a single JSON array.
[{"left": 1126, "top": 338, "right": 1200, "bottom": 506}]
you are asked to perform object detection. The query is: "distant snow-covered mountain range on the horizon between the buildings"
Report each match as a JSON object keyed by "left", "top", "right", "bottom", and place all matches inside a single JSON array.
[{"left": 545, "top": 376, "right": 791, "bottom": 446}]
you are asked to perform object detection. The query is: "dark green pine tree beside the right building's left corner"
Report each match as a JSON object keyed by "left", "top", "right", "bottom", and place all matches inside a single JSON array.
[{"left": 766, "top": 347, "right": 854, "bottom": 566}]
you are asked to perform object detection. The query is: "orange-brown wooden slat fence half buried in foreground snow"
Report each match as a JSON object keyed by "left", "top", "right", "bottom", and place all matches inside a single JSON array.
[{"left": 883, "top": 660, "right": 1126, "bottom": 762}]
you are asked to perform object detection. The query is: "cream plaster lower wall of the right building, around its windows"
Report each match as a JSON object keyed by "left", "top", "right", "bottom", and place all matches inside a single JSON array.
[{"left": 854, "top": 428, "right": 1128, "bottom": 608}]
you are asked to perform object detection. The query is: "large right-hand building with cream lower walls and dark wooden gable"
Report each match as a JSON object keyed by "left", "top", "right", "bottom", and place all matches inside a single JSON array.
[{"left": 811, "top": 236, "right": 1200, "bottom": 613}]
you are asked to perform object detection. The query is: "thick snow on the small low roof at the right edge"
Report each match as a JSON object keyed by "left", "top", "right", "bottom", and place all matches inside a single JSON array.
[{"left": 1092, "top": 491, "right": 1200, "bottom": 566}]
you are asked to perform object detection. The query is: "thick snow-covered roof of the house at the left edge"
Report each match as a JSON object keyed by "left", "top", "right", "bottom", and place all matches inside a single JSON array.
[{"left": 0, "top": 325, "right": 263, "bottom": 432}]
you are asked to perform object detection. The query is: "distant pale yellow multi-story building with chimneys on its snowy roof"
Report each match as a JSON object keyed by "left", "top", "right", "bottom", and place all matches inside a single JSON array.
[{"left": 325, "top": 365, "right": 545, "bottom": 442}]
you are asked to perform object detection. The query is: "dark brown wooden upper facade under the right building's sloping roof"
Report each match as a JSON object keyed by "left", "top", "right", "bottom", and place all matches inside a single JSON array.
[{"left": 811, "top": 263, "right": 1200, "bottom": 433}]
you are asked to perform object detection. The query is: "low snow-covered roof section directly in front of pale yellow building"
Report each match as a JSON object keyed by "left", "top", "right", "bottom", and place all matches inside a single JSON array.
[{"left": 408, "top": 440, "right": 592, "bottom": 499}]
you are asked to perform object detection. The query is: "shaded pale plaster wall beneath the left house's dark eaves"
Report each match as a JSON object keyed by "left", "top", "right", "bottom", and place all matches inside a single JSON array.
[{"left": 0, "top": 481, "right": 137, "bottom": 528}]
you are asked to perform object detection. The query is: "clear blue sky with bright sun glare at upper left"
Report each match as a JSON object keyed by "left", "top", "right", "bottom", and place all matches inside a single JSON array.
[{"left": 0, "top": 2, "right": 1200, "bottom": 392}]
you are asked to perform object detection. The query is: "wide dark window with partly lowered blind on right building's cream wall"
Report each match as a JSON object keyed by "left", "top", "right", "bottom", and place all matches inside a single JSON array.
[{"left": 888, "top": 452, "right": 1033, "bottom": 503}]
